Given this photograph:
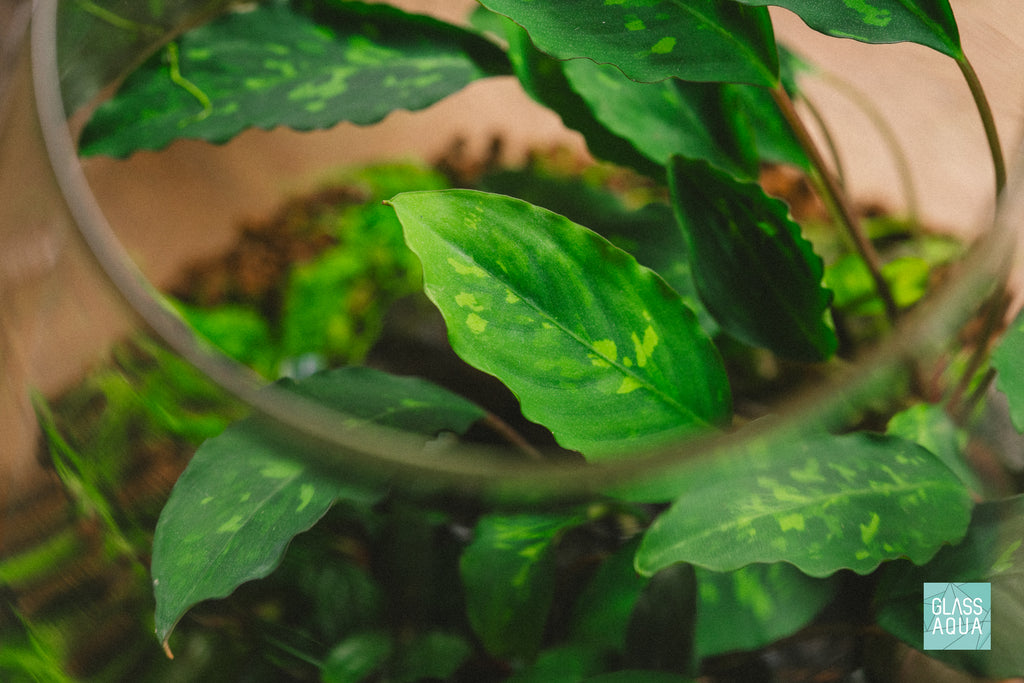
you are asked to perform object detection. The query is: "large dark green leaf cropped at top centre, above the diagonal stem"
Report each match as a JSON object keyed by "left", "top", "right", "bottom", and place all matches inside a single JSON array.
[{"left": 480, "top": 0, "right": 778, "bottom": 86}]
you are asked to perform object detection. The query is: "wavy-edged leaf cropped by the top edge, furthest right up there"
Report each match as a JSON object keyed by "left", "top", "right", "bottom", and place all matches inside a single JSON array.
[{"left": 735, "top": 0, "right": 964, "bottom": 59}]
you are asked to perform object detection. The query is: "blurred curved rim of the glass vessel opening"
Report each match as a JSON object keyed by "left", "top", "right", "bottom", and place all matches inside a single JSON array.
[{"left": 32, "top": 0, "right": 1024, "bottom": 505}]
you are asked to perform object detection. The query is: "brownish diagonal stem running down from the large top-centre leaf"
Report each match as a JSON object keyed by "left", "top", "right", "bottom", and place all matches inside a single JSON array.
[{"left": 770, "top": 85, "right": 899, "bottom": 324}]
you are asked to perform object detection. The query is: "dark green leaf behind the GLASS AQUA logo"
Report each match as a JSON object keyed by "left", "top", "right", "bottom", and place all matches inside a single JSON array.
[{"left": 874, "top": 496, "right": 1024, "bottom": 679}]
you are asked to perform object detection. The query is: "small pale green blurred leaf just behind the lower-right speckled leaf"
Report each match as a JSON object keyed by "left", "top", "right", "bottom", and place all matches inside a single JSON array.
[{"left": 886, "top": 403, "right": 982, "bottom": 494}]
